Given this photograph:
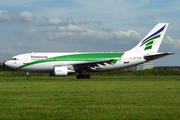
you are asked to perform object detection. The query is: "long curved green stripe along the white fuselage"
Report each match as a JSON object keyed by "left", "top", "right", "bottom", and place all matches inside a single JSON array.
[{"left": 17, "top": 53, "right": 124, "bottom": 69}]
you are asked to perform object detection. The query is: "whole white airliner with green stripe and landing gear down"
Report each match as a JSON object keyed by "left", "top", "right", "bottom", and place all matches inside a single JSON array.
[{"left": 5, "top": 23, "right": 174, "bottom": 79}]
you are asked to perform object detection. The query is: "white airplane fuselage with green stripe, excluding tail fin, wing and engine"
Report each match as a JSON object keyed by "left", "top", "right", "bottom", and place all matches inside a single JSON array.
[{"left": 5, "top": 53, "right": 146, "bottom": 72}]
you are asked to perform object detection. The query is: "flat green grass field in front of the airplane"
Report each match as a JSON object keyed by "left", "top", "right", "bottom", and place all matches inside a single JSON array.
[{"left": 0, "top": 76, "right": 180, "bottom": 120}]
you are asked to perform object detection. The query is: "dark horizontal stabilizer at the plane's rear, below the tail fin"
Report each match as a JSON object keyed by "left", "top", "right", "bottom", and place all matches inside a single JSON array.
[{"left": 144, "top": 52, "right": 174, "bottom": 61}]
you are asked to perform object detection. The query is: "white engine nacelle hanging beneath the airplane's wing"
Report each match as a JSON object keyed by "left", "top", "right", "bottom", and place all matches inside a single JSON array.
[{"left": 54, "top": 67, "right": 68, "bottom": 77}]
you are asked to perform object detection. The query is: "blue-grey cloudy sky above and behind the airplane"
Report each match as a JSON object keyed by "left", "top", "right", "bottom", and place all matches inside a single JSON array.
[{"left": 0, "top": 0, "right": 180, "bottom": 66}]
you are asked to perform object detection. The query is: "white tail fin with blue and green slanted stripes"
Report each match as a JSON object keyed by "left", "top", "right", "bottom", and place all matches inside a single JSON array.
[{"left": 127, "top": 23, "right": 169, "bottom": 53}]
